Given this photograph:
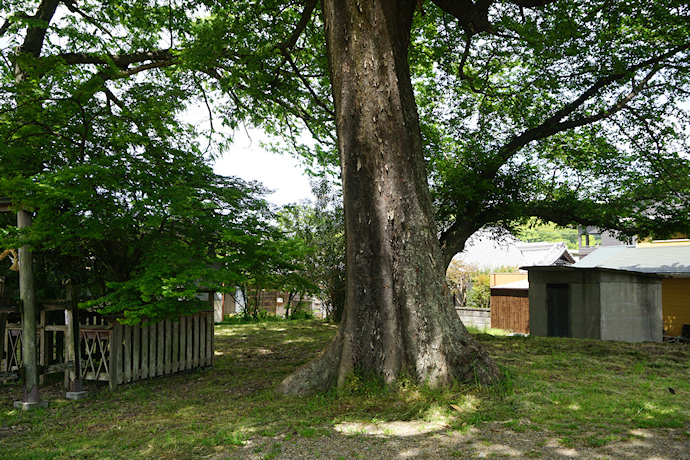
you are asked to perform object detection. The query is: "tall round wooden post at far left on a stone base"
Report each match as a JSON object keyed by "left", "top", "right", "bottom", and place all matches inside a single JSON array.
[{"left": 15, "top": 209, "right": 48, "bottom": 409}]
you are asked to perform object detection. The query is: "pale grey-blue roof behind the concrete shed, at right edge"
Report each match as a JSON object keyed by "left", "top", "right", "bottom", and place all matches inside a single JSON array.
[{"left": 573, "top": 245, "right": 690, "bottom": 275}]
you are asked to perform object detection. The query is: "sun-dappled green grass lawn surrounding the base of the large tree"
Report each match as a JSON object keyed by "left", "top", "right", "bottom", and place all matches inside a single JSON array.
[{"left": 0, "top": 321, "right": 690, "bottom": 459}]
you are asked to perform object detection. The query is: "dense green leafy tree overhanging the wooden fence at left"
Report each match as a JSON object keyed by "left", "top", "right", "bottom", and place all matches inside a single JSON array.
[{"left": 0, "top": 1, "right": 310, "bottom": 322}]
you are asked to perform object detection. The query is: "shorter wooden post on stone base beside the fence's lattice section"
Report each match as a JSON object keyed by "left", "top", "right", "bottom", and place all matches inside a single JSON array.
[{"left": 65, "top": 280, "right": 87, "bottom": 399}]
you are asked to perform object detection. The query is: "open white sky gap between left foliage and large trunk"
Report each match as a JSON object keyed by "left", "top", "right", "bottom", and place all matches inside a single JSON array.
[{"left": 214, "top": 130, "right": 313, "bottom": 206}]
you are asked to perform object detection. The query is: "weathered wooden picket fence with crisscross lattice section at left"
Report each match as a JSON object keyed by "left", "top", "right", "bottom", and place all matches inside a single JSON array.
[{"left": 0, "top": 310, "right": 214, "bottom": 390}]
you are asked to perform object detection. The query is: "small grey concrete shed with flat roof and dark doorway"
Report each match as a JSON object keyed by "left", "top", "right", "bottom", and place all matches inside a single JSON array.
[{"left": 527, "top": 266, "right": 663, "bottom": 342}]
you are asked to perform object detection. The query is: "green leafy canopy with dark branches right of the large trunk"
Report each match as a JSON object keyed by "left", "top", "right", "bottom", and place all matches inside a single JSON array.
[{"left": 414, "top": 1, "right": 690, "bottom": 266}]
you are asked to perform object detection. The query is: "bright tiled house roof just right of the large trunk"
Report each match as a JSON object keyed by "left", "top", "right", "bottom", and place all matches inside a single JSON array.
[{"left": 455, "top": 232, "right": 575, "bottom": 269}]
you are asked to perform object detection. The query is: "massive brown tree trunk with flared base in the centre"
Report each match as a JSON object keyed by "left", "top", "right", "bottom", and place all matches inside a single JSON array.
[{"left": 279, "top": 0, "right": 500, "bottom": 394}]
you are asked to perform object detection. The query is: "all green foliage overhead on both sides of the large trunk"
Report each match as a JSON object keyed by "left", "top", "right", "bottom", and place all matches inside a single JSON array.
[{"left": 0, "top": 0, "right": 690, "bottom": 320}]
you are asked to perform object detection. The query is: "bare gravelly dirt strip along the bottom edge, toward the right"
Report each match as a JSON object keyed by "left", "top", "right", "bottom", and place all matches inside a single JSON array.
[{"left": 232, "top": 422, "right": 690, "bottom": 460}]
